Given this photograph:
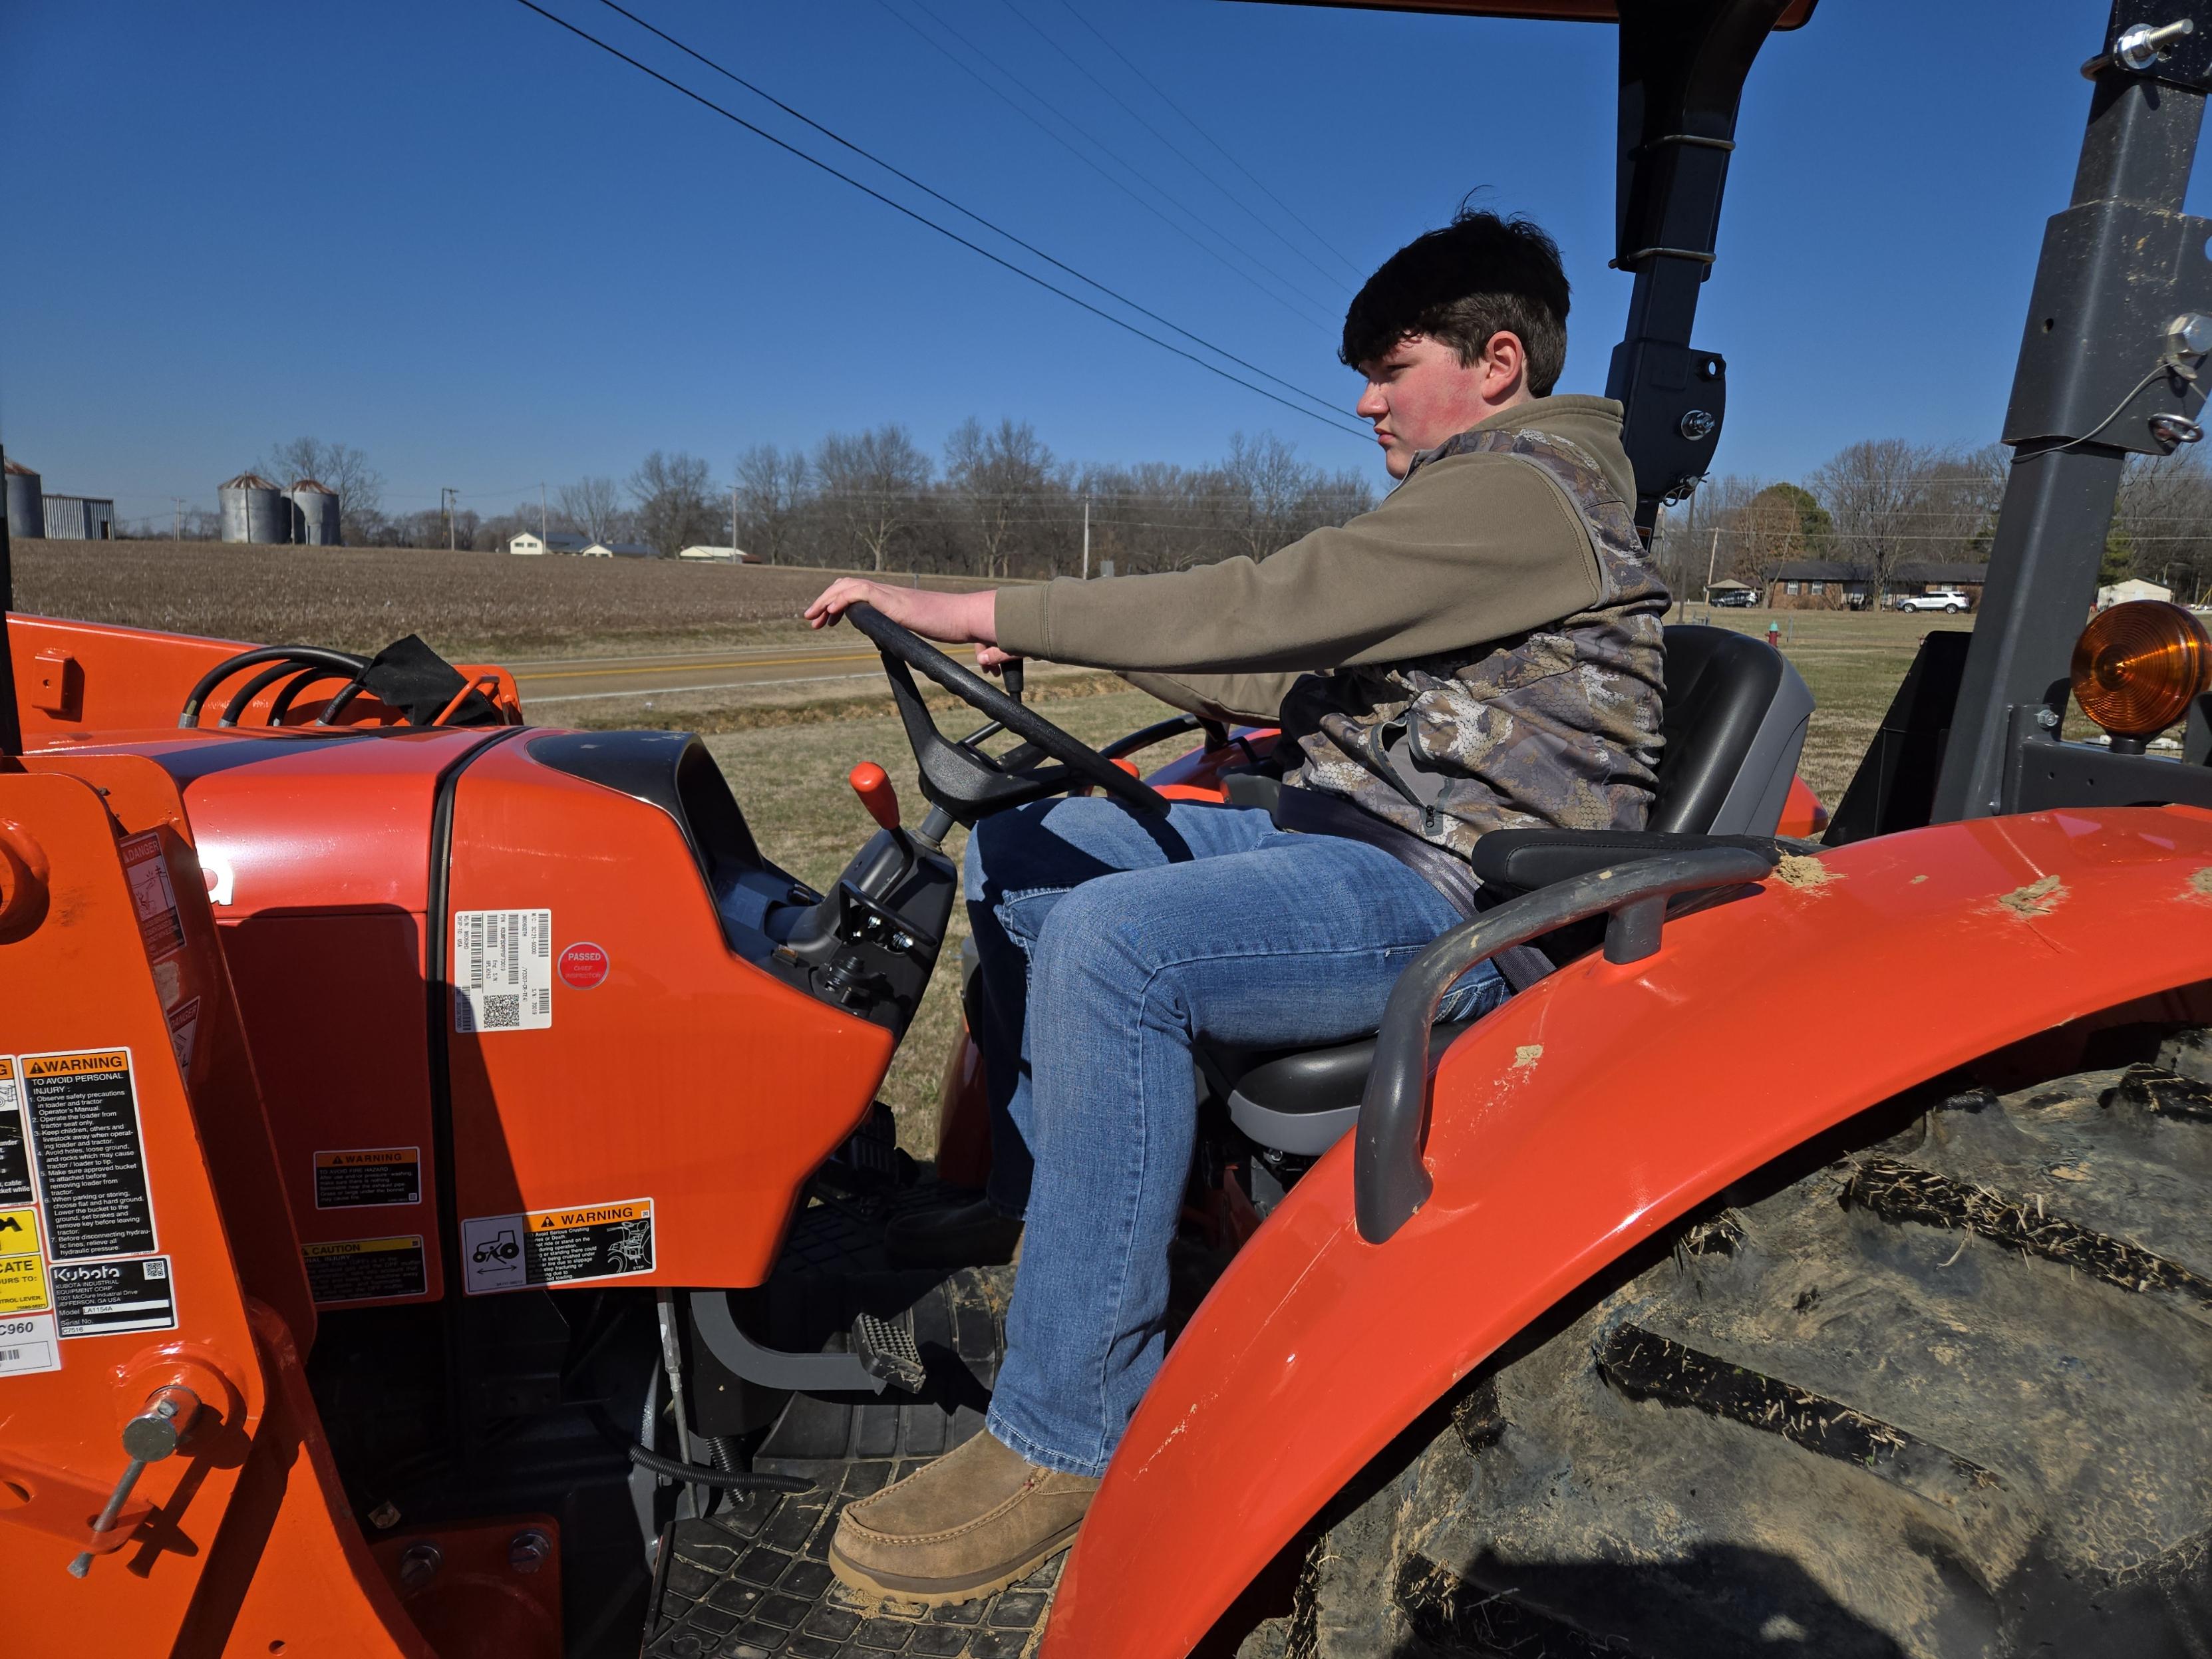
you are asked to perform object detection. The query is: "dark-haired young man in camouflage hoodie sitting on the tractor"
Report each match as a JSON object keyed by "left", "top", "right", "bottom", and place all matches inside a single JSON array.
[{"left": 808, "top": 210, "right": 1668, "bottom": 1602}]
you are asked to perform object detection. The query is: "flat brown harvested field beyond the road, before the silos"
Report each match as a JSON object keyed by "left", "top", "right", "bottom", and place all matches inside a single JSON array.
[{"left": 13, "top": 539, "right": 1004, "bottom": 661}]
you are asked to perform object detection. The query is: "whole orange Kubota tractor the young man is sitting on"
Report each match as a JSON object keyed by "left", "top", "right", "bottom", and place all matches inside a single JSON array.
[{"left": 0, "top": 0, "right": 2212, "bottom": 1659}]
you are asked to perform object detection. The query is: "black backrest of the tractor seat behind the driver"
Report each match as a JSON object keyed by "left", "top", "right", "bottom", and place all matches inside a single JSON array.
[{"left": 1646, "top": 624, "right": 1812, "bottom": 836}]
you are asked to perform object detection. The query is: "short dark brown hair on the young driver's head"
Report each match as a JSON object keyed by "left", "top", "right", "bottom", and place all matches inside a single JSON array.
[{"left": 1339, "top": 208, "right": 1568, "bottom": 398}]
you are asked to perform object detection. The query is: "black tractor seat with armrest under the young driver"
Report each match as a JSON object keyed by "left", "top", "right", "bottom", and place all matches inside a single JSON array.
[{"left": 1199, "top": 626, "right": 1814, "bottom": 1157}]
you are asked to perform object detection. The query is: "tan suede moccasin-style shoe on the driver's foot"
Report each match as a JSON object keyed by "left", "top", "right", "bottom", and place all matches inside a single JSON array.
[{"left": 830, "top": 1429, "right": 1100, "bottom": 1606}]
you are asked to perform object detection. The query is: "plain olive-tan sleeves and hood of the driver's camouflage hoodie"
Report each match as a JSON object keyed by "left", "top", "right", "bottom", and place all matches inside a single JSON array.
[{"left": 998, "top": 396, "right": 1637, "bottom": 721}]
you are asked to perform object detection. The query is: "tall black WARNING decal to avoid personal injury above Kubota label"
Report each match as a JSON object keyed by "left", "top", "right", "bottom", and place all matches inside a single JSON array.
[{"left": 22, "top": 1048, "right": 155, "bottom": 1256}]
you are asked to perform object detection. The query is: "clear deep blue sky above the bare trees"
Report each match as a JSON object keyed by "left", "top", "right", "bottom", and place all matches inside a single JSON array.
[{"left": 0, "top": 0, "right": 2212, "bottom": 533}]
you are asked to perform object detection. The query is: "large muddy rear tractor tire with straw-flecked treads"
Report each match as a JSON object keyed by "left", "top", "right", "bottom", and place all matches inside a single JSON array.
[{"left": 1274, "top": 1033, "right": 2212, "bottom": 1659}]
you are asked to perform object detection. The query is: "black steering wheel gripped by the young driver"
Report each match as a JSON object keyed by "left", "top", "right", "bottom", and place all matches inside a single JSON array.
[{"left": 845, "top": 604, "right": 1168, "bottom": 825}]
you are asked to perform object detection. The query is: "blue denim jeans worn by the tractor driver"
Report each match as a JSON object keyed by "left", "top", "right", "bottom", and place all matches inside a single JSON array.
[{"left": 967, "top": 796, "right": 1506, "bottom": 1475}]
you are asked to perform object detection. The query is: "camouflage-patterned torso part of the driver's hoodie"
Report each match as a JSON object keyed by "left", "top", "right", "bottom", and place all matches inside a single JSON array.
[{"left": 1283, "top": 431, "right": 1668, "bottom": 856}]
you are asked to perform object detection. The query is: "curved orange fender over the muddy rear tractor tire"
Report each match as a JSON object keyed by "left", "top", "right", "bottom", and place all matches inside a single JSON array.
[{"left": 1044, "top": 808, "right": 2212, "bottom": 1659}]
